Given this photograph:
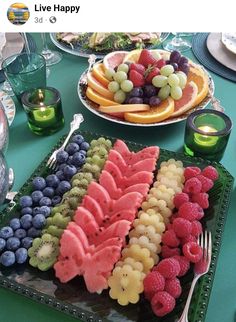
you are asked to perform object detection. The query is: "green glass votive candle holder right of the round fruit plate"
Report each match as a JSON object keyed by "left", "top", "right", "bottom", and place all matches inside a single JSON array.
[{"left": 184, "top": 109, "right": 232, "bottom": 161}]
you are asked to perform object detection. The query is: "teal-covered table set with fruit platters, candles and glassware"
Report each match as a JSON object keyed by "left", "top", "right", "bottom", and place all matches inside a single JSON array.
[{"left": 0, "top": 33, "right": 236, "bottom": 322}]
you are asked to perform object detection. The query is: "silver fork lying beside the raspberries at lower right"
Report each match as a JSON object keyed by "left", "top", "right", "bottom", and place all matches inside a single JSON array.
[{"left": 177, "top": 231, "right": 212, "bottom": 322}]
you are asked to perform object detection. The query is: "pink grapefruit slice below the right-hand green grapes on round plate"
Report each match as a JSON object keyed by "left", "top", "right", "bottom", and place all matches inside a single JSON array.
[{"left": 171, "top": 82, "right": 198, "bottom": 117}]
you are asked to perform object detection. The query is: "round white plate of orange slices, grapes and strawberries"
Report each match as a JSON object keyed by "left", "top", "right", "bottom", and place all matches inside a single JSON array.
[{"left": 78, "top": 49, "right": 214, "bottom": 127}]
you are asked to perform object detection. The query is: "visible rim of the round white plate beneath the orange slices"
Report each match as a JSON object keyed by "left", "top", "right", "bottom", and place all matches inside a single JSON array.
[{"left": 77, "top": 61, "right": 215, "bottom": 127}]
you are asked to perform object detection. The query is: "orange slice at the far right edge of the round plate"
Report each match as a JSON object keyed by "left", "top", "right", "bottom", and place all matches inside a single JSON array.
[{"left": 188, "top": 62, "right": 209, "bottom": 107}]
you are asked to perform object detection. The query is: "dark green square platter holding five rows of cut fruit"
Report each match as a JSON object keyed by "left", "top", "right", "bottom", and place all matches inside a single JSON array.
[{"left": 0, "top": 132, "right": 233, "bottom": 322}]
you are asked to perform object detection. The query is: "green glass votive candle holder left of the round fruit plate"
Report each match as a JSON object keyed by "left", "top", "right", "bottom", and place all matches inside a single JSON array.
[{"left": 21, "top": 87, "right": 64, "bottom": 135}]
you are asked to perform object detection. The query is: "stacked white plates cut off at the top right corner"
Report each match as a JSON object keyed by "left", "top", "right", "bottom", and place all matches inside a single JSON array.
[{"left": 206, "top": 32, "right": 236, "bottom": 71}]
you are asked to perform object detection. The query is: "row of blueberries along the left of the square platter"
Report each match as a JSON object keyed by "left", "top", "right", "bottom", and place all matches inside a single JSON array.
[{"left": 0, "top": 134, "right": 89, "bottom": 266}]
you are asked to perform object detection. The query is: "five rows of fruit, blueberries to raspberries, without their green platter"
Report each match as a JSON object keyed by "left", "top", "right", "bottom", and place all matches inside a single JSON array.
[{"left": 0, "top": 135, "right": 218, "bottom": 316}]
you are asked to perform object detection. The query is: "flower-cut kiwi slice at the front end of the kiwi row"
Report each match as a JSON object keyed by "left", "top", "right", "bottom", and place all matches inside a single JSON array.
[{"left": 28, "top": 234, "right": 59, "bottom": 271}]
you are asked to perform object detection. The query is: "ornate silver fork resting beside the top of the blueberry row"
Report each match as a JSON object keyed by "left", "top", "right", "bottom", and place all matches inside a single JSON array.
[{"left": 46, "top": 114, "right": 84, "bottom": 169}]
